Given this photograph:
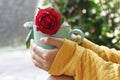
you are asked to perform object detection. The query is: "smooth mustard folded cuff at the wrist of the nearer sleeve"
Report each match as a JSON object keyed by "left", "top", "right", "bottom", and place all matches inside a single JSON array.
[{"left": 48, "top": 39, "right": 76, "bottom": 75}]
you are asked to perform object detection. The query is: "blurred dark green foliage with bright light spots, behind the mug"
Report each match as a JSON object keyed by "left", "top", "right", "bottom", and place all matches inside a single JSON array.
[{"left": 50, "top": 0, "right": 120, "bottom": 49}]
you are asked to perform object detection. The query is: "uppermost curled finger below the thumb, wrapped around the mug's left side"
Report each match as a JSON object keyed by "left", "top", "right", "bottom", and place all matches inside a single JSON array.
[{"left": 30, "top": 40, "right": 45, "bottom": 58}]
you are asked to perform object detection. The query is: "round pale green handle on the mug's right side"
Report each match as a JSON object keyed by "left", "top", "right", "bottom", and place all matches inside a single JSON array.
[{"left": 70, "top": 29, "right": 85, "bottom": 44}]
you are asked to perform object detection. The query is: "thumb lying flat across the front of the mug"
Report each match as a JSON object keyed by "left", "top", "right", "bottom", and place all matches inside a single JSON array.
[{"left": 40, "top": 37, "right": 64, "bottom": 48}]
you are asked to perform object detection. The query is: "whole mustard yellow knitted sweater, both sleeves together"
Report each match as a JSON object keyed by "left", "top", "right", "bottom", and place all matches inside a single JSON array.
[{"left": 48, "top": 39, "right": 120, "bottom": 80}]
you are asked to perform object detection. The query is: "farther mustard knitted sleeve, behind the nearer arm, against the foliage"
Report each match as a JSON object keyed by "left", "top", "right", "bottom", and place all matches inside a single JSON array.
[{"left": 81, "top": 39, "right": 120, "bottom": 64}]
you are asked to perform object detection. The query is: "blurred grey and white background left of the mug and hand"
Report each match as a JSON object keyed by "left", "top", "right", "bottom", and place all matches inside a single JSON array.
[{"left": 0, "top": 0, "right": 48, "bottom": 80}]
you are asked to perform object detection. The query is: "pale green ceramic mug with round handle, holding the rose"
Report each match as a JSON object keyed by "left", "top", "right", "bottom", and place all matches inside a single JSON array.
[{"left": 33, "top": 25, "right": 84, "bottom": 49}]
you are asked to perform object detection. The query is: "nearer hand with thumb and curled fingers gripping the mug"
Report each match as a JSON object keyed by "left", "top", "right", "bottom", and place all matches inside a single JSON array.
[{"left": 30, "top": 37, "right": 64, "bottom": 71}]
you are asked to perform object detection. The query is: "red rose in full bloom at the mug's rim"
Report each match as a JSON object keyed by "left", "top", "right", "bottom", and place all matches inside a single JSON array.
[{"left": 35, "top": 9, "right": 60, "bottom": 35}]
